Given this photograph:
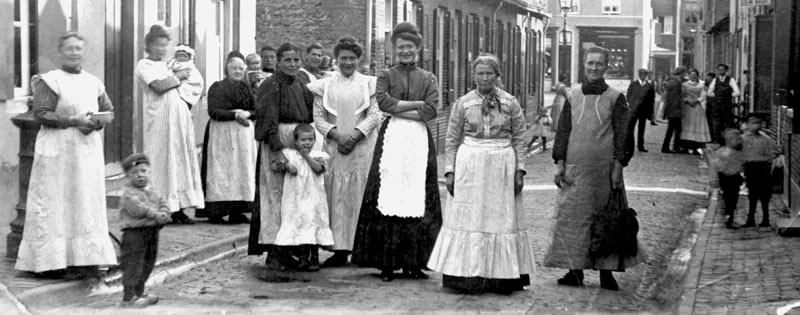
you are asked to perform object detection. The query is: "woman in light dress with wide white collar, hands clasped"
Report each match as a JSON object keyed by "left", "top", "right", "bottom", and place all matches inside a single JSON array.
[{"left": 308, "top": 37, "right": 383, "bottom": 267}]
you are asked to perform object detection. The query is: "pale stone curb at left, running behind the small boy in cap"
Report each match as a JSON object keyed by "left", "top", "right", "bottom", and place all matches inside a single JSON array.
[{"left": 17, "top": 233, "right": 248, "bottom": 309}]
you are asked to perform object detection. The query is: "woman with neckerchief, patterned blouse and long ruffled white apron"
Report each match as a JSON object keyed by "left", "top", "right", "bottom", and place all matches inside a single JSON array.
[{"left": 428, "top": 55, "right": 536, "bottom": 294}]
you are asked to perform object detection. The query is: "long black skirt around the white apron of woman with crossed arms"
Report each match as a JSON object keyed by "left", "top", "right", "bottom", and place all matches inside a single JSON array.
[{"left": 352, "top": 118, "right": 442, "bottom": 269}]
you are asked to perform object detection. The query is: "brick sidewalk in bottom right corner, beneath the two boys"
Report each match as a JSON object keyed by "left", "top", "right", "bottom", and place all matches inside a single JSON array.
[{"left": 681, "top": 167, "right": 800, "bottom": 314}]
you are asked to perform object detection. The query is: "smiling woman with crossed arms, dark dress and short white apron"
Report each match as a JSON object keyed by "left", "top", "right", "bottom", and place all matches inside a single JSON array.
[{"left": 352, "top": 23, "right": 442, "bottom": 281}]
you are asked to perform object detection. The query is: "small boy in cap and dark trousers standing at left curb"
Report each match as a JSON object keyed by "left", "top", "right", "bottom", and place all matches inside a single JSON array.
[{"left": 119, "top": 153, "right": 170, "bottom": 307}]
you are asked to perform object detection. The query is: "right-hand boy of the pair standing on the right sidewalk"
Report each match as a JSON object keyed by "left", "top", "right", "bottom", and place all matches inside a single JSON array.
[{"left": 742, "top": 113, "right": 778, "bottom": 227}]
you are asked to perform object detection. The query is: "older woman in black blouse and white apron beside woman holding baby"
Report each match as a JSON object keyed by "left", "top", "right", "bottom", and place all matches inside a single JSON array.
[{"left": 195, "top": 51, "right": 258, "bottom": 224}]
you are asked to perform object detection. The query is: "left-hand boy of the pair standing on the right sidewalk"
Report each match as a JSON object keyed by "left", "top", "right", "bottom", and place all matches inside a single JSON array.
[{"left": 709, "top": 129, "right": 743, "bottom": 229}]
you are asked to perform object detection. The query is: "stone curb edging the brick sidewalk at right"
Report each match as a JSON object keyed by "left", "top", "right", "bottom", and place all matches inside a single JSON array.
[{"left": 673, "top": 190, "right": 719, "bottom": 314}]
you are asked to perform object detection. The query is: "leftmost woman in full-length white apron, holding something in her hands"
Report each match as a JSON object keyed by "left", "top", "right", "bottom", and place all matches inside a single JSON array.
[{"left": 15, "top": 33, "right": 117, "bottom": 274}]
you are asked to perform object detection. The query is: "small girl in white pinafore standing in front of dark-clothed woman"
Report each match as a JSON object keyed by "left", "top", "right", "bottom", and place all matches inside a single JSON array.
[{"left": 275, "top": 124, "right": 333, "bottom": 271}]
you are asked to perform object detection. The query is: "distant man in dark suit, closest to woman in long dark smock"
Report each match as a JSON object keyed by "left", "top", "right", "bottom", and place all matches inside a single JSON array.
[{"left": 625, "top": 69, "right": 656, "bottom": 152}]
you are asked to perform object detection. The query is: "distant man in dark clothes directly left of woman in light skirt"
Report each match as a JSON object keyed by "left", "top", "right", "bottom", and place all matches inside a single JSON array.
[{"left": 661, "top": 67, "right": 686, "bottom": 153}]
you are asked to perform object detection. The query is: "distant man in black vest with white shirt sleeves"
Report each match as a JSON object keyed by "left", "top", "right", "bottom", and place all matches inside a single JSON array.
[{"left": 707, "top": 64, "right": 740, "bottom": 144}]
